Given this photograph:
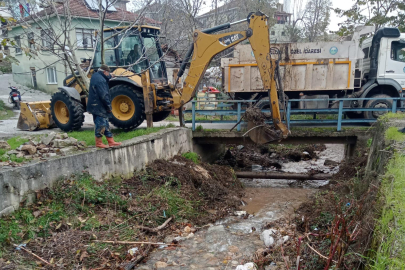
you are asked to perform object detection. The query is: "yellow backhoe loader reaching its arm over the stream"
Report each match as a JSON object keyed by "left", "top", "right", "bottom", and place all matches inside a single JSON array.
[{"left": 18, "top": 12, "right": 289, "bottom": 141}]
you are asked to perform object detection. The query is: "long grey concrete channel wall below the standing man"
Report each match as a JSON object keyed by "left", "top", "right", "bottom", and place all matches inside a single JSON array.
[{"left": 0, "top": 128, "right": 193, "bottom": 216}]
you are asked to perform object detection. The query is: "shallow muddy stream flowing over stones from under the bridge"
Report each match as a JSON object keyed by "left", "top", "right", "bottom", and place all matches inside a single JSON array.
[{"left": 137, "top": 145, "right": 344, "bottom": 270}]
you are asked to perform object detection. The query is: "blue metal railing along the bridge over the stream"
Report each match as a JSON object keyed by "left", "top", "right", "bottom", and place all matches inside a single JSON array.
[{"left": 184, "top": 97, "right": 405, "bottom": 131}]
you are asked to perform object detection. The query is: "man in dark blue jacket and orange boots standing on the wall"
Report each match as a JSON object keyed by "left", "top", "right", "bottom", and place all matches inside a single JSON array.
[{"left": 87, "top": 65, "right": 121, "bottom": 148}]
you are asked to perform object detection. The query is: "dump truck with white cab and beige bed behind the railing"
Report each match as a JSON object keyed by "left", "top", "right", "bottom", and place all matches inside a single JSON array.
[{"left": 221, "top": 26, "right": 405, "bottom": 119}]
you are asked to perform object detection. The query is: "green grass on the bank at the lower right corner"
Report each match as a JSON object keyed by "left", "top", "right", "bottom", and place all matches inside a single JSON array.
[{"left": 372, "top": 153, "right": 405, "bottom": 270}]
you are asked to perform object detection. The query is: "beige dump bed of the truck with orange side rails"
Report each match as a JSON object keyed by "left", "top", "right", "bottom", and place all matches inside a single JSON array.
[{"left": 221, "top": 41, "right": 364, "bottom": 93}]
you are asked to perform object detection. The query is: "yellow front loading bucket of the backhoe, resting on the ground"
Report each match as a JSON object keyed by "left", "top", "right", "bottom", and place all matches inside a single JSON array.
[{"left": 17, "top": 101, "right": 55, "bottom": 131}]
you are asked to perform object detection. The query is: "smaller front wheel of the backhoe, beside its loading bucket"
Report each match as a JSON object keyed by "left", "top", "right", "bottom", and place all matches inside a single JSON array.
[{"left": 51, "top": 92, "right": 84, "bottom": 132}]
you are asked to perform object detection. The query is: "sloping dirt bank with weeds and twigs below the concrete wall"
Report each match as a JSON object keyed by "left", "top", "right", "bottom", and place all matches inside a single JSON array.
[{"left": 0, "top": 156, "right": 243, "bottom": 269}]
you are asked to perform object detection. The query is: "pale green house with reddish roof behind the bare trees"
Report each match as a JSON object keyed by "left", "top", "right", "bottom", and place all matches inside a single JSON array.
[{"left": 7, "top": 0, "right": 159, "bottom": 93}]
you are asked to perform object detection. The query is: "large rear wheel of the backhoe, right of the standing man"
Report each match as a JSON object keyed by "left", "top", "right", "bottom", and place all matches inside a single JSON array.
[{"left": 110, "top": 84, "right": 145, "bottom": 130}]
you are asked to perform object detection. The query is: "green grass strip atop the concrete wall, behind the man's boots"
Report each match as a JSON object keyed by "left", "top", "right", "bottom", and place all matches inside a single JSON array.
[{"left": 68, "top": 124, "right": 174, "bottom": 146}]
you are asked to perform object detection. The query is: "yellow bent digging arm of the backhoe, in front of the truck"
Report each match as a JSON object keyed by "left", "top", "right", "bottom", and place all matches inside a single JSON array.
[{"left": 172, "top": 12, "right": 289, "bottom": 137}]
